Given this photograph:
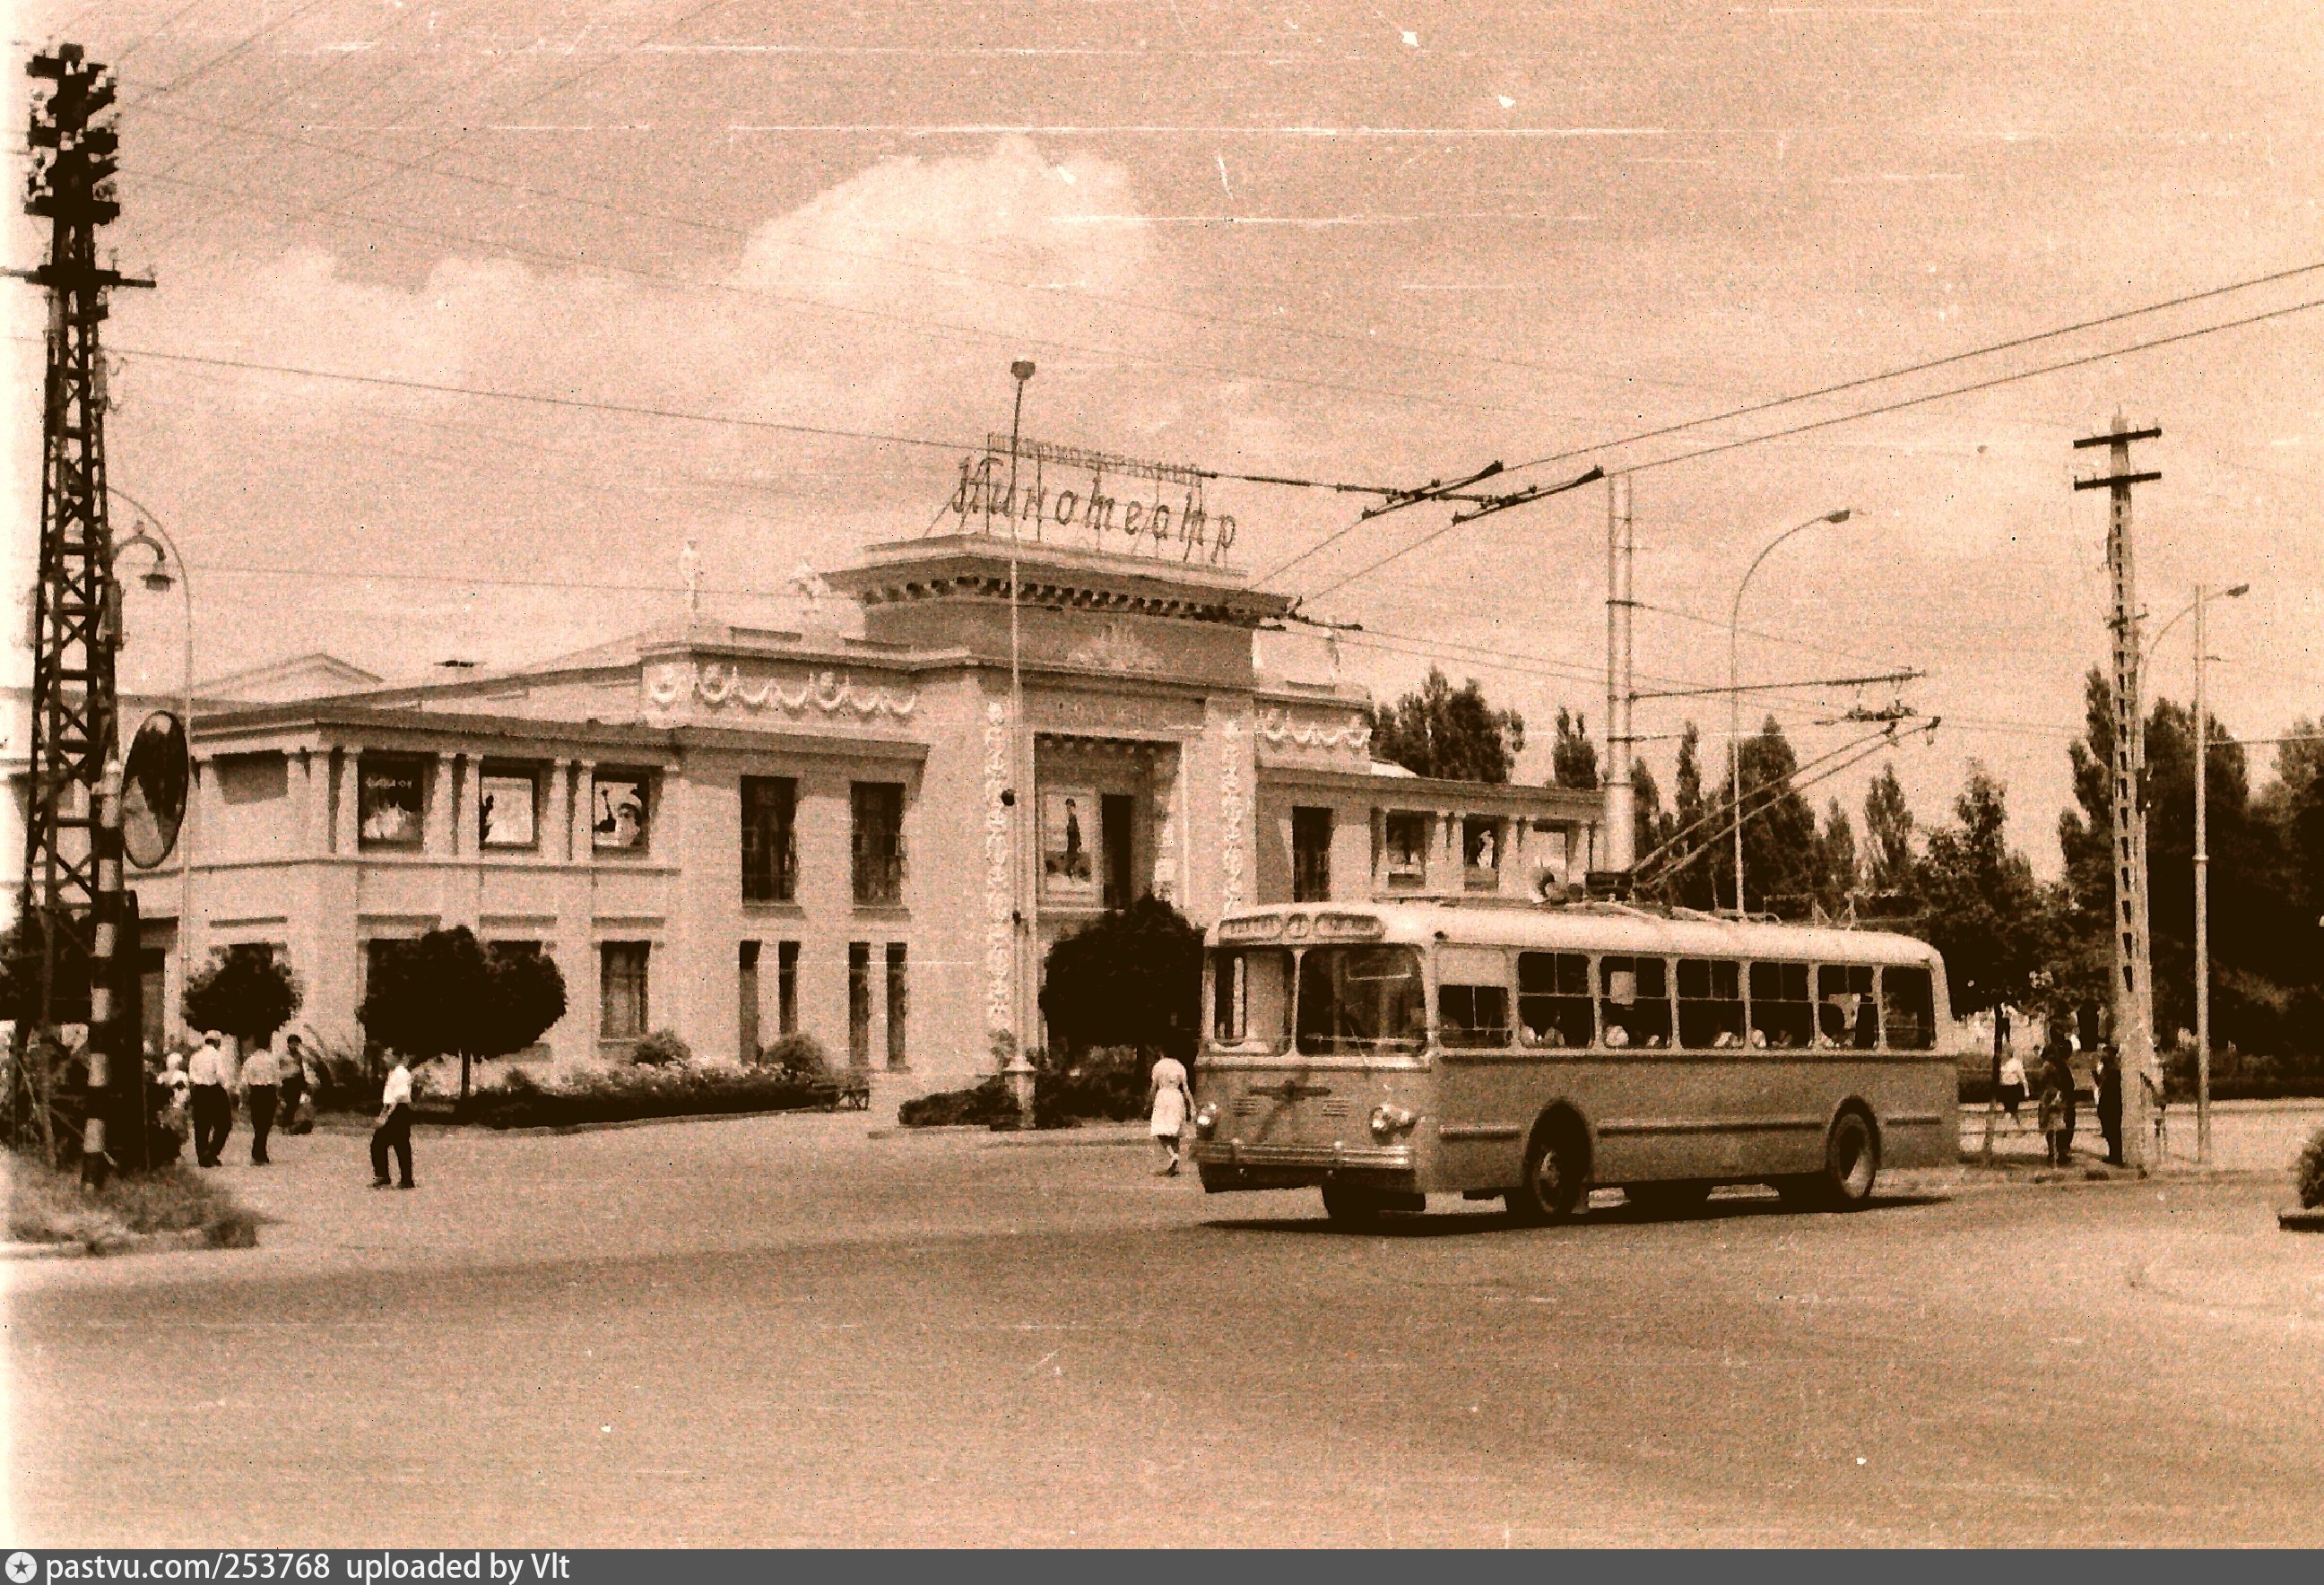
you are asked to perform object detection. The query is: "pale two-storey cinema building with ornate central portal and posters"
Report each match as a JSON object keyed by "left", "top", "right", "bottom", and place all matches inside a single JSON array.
[{"left": 9, "top": 530, "right": 1601, "bottom": 1087}]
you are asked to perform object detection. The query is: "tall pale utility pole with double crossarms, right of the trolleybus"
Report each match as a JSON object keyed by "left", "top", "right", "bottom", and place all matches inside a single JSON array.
[{"left": 2073, "top": 409, "right": 2165, "bottom": 1169}]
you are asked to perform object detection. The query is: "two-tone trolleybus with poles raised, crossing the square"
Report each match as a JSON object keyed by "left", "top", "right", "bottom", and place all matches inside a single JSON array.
[{"left": 1192, "top": 899, "right": 1956, "bottom": 1225}]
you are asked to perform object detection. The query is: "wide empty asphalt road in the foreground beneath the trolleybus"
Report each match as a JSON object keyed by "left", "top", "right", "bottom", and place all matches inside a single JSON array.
[{"left": 7, "top": 1121, "right": 2324, "bottom": 1546}]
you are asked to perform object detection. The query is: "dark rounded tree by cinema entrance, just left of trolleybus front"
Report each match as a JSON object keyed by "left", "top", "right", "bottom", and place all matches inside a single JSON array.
[{"left": 1041, "top": 892, "right": 1201, "bottom": 1062}]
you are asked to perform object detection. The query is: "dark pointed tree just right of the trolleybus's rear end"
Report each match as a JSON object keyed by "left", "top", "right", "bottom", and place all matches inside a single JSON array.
[{"left": 1915, "top": 760, "right": 2048, "bottom": 1013}]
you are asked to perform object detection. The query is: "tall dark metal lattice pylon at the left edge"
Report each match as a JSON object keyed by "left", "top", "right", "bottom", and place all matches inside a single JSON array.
[{"left": 9, "top": 44, "right": 151, "bottom": 1181}]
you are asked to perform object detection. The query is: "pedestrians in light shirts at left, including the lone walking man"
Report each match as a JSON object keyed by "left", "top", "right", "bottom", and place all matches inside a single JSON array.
[{"left": 158, "top": 1029, "right": 416, "bottom": 1188}]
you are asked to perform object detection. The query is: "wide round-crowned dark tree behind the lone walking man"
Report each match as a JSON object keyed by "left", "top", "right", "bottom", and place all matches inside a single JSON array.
[{"left": 356, "top": 925, "right": 565, "bottom": 1099}]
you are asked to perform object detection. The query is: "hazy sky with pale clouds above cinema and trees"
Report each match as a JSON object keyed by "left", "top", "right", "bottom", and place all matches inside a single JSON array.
[{"left": 0, "top": 0, "right": 2324, "bottom": 871}]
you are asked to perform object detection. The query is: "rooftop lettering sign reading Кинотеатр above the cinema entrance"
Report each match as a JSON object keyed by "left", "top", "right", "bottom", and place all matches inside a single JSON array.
[{"left": 950, "top": 435, "right": 1234, "bottom": 567}]
